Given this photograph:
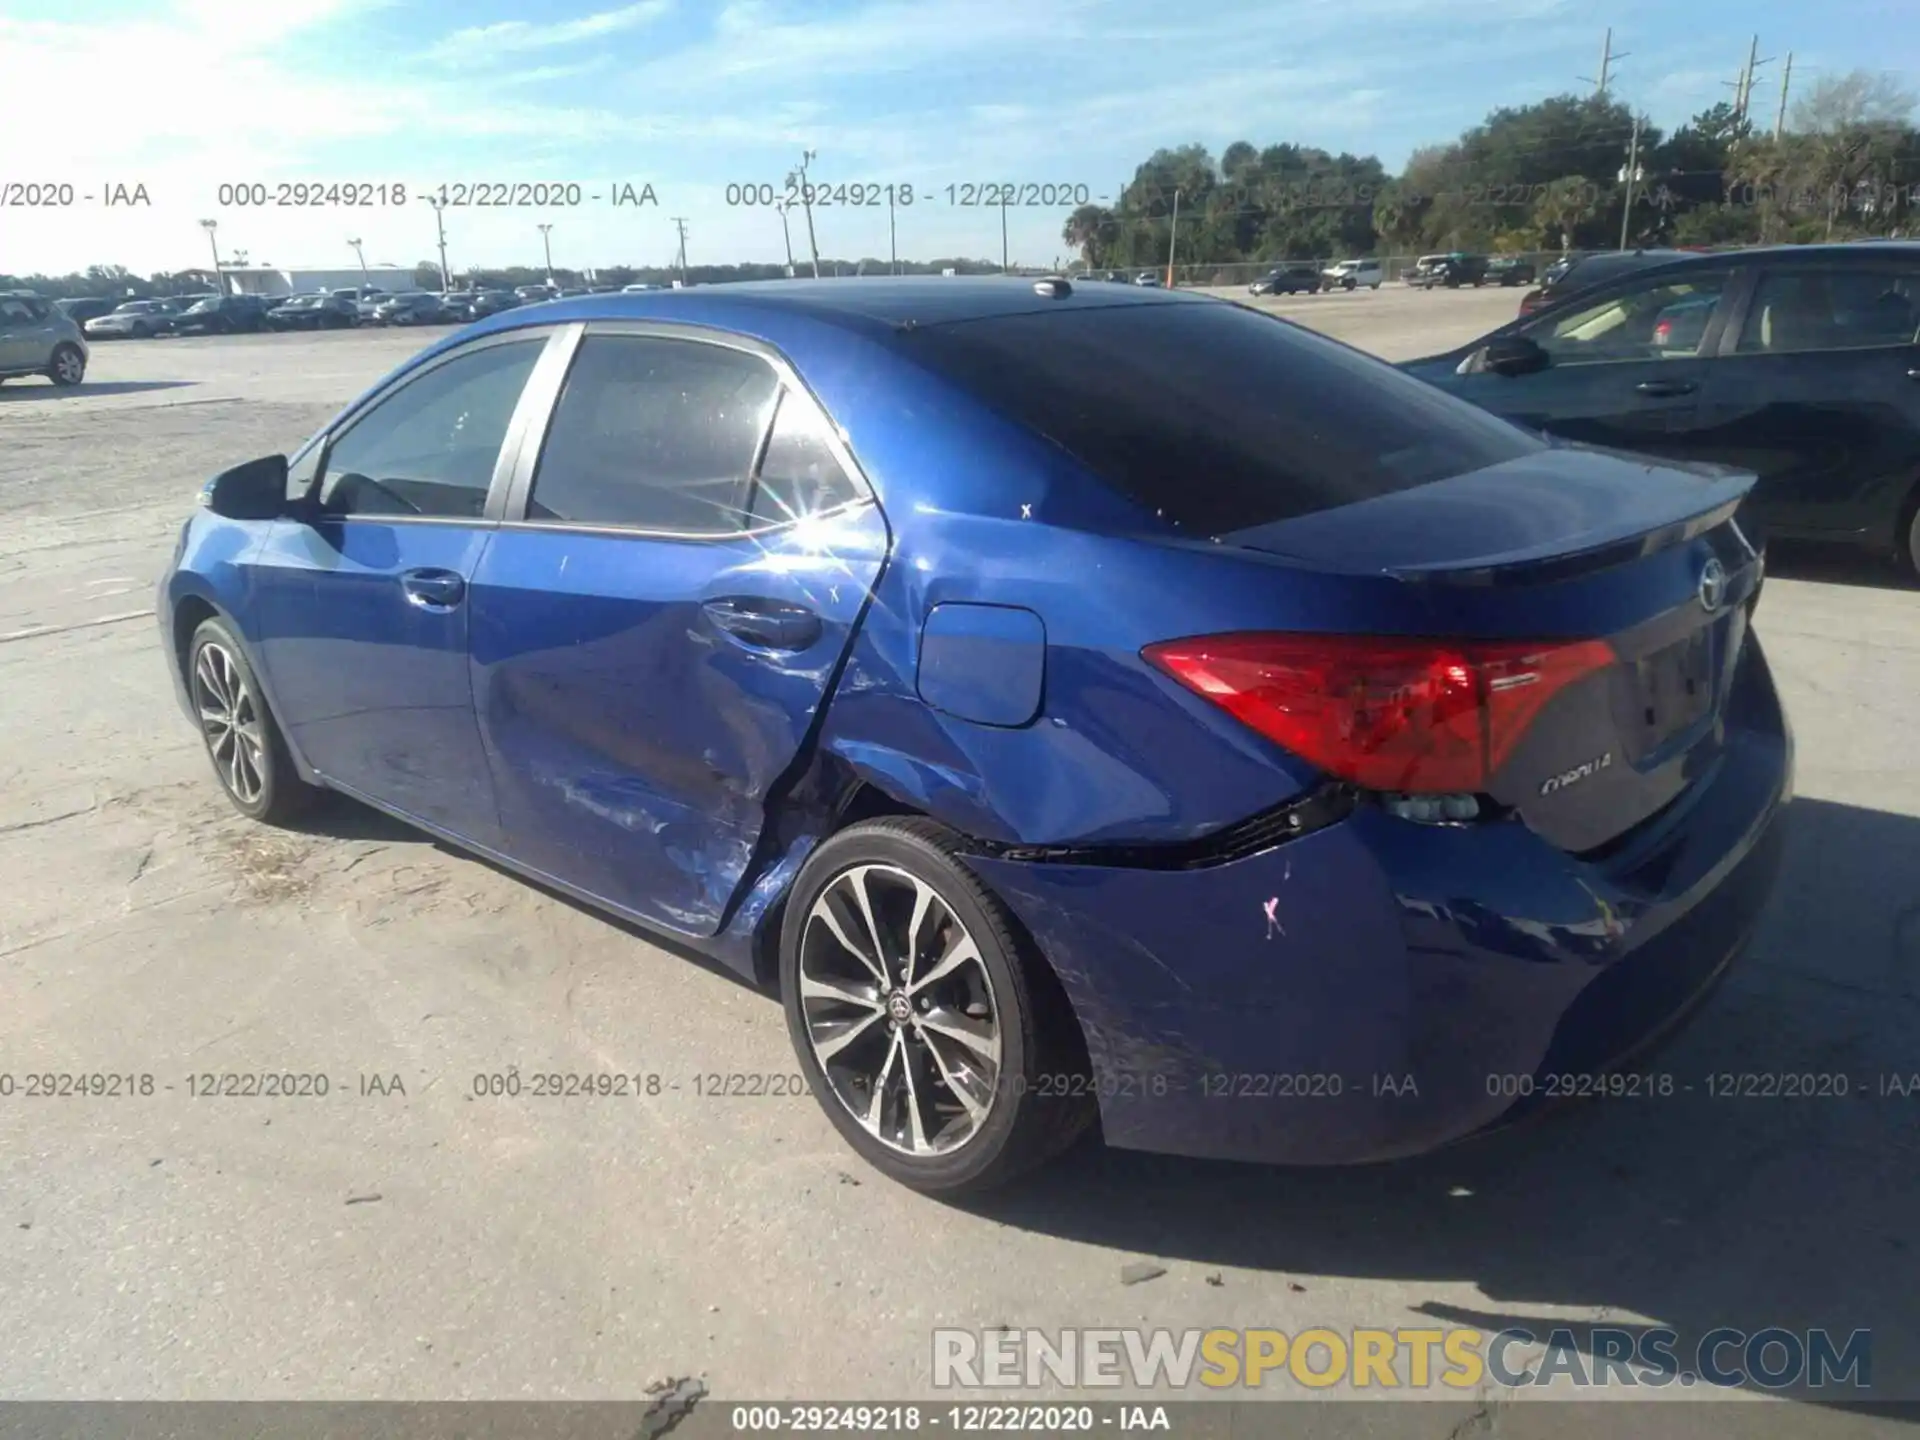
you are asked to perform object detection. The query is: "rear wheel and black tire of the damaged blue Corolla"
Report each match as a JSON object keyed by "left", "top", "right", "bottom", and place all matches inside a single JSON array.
[{"left": 780, "top": 820, "right": 1092, "bottom": 1196}]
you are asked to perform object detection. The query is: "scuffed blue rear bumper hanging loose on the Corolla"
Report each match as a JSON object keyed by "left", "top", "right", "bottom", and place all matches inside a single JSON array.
[{"left": 970, "top": 649, "right": 1793, "bottom": 1165}]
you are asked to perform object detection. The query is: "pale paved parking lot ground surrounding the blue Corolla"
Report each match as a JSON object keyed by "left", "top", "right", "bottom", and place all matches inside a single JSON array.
[{"left": 0, "top": 288, "right": 1920, "bottom": 1438}]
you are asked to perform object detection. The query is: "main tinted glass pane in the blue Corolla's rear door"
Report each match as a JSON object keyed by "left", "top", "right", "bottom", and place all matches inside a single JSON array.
[{"left": 526, "top": 336, "right": 780, "bottom": 536}]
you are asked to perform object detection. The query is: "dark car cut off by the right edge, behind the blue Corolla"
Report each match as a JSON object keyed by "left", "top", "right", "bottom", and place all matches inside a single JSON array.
[{"left": 1407, "top": 240, "right": 1920, "bottom": 574}]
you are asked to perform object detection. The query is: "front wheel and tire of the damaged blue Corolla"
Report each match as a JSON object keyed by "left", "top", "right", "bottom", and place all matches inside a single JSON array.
[{"left": 186, "top": 620, "right": 319, "bottom": 826}]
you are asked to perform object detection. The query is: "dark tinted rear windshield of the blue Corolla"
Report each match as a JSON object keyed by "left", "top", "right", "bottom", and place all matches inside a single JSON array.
[{"left": 900, "top": 301, "right": 1544, "bottom": 536}]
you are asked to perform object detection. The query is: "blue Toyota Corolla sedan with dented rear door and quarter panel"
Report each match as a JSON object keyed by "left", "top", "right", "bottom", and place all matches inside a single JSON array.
[{"left": 159, "top": 276, "right": 1793, "bottom": 1194}]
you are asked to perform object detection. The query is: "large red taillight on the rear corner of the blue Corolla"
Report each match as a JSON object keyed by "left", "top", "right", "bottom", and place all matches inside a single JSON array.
[{"left": 1142, "top": 634, "right": 1615, "bottom": 795}]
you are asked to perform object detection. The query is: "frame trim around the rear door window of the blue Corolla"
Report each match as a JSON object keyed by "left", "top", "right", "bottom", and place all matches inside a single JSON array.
[{"left": 495, "top": 321, "right": 877, "bottom": 543}]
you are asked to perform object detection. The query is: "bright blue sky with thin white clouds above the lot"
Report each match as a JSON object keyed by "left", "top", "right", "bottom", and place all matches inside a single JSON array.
[{"left": 0, "top": 0, "right": 1920, "bottom": 273}]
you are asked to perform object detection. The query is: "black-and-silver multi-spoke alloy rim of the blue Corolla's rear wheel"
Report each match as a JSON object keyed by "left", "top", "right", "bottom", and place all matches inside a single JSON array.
[{"left": 799, "top": 864, "right": 1000, "bottom": 1158}]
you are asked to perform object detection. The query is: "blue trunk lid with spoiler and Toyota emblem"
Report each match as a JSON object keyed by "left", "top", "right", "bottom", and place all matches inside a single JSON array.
[{"left": 1221, "top": 445, "right": 1763, "bottom": 854}]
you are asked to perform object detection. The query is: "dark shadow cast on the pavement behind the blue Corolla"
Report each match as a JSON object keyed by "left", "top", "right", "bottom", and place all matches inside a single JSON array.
[{"left": 979, "top": 799, "right": 1920, "bottom": 1402}]
